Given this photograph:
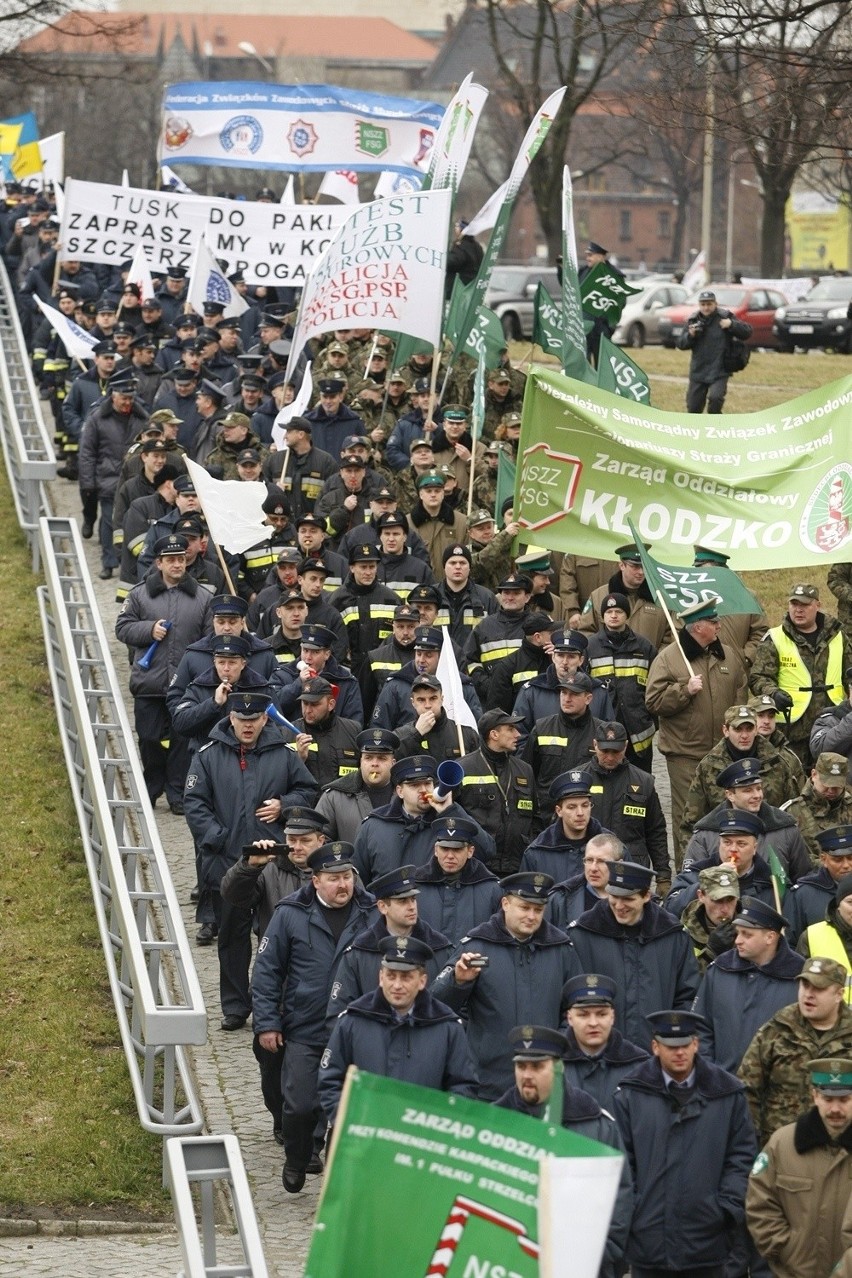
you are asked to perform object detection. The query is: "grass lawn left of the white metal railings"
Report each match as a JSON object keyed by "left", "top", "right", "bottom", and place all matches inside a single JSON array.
[{"left": 0, "top": 472, "right": 171, "bottom": 1219}]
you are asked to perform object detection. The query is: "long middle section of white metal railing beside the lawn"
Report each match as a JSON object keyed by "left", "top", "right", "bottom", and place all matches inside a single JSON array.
[{"left": 38, "top": 519, "right": 207, "bottom": 1136}]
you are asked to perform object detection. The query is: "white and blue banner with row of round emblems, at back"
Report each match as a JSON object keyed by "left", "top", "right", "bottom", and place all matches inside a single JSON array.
[{"left": 158, "top": 81, "right": 443, "bottom": 173}]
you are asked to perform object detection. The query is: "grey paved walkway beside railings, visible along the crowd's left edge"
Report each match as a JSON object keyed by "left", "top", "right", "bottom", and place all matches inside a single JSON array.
[{"left": 0, "top": 481, "right": 669, "bottom": 1278}]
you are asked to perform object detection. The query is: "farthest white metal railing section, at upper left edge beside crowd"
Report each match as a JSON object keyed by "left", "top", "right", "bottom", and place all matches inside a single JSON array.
[{"left": 0, "top": 261, "right": 56, "bottom": 571}]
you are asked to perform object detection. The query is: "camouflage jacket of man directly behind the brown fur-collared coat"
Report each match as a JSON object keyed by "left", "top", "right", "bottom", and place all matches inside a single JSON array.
[{"left": 737, "top": 1003, "right": 852, "bottom": 1145}]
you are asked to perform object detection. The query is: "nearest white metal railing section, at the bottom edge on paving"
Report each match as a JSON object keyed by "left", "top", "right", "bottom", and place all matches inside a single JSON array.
[{"left": 166, "top": 1136, "right": 268, "bottom": 1278}]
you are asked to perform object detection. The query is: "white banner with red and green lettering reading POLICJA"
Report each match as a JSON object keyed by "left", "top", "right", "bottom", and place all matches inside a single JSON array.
[{"left": 290, "top": 190, "right": 452, "bottom": 364}]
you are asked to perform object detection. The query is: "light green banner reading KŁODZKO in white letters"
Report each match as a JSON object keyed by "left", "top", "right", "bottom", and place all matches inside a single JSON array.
[{"left": 515, "top": 364, "right": 852, "bottom": 571}]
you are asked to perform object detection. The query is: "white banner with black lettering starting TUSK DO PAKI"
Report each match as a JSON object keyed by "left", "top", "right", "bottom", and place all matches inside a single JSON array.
[{"left": 60, "top": 179, "right": 351, "bottom": 285}]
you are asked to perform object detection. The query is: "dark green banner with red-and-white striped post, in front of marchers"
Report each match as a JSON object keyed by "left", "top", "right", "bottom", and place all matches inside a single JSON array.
[{"left": 304, "top": 1071, "right": 620, "bottom": 1278}]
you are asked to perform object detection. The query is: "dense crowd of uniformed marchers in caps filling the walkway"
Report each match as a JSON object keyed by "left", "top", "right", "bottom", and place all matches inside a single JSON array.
[{"left": 4, "top": 191, "right": 852, "bottom": 1278}]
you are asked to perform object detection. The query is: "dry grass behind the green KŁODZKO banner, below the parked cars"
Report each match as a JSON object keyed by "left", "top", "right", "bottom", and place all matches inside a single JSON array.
[{"left": 510, "top": 343, "right": 852, "bottom": 625}]
